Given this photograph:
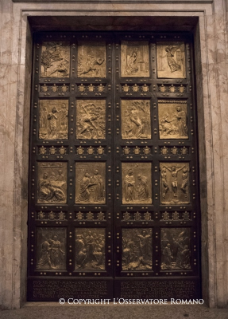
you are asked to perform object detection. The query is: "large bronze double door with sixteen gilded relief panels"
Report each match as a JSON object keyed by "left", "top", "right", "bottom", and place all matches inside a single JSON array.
[{"left": 28, "top": 32, "right": 200, "bottom": 301}]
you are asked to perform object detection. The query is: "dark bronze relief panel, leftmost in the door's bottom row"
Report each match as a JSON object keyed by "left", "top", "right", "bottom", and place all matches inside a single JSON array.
[{"left": 36, "top": 228, "right": 66, "bottom": 270}]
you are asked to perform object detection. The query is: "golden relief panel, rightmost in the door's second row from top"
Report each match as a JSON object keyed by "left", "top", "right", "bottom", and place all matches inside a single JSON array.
[{"left": 158, "top": 101, "right": 188, "bottom": 139}]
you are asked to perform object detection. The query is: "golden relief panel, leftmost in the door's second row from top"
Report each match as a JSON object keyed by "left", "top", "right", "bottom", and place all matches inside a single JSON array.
[{"left": 39, "top": 100, "right": 68, "bottom": 140}]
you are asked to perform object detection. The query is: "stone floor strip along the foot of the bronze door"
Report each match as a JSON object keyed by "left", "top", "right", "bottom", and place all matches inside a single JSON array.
[{"left": 0, "top": 303, "right": 228, "bottom": 319}]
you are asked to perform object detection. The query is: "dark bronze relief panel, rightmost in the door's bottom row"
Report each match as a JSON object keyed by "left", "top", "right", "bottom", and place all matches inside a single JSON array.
[{"left": 161, "top": 228, "right": 191, "bottom": 270}]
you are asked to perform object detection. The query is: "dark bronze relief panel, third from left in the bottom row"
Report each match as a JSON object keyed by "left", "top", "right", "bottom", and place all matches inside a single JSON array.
[{"left": 122, "top": 228, "right": 152, "bottom": 271}]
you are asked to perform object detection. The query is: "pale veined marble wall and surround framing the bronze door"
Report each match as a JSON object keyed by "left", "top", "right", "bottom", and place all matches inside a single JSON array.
[{"left": 0, "top": 0, "right": 228, "bottom": 309}]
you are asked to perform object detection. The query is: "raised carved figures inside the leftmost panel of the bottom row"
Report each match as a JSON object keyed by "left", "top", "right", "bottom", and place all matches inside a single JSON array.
[{"left": 37, "top": 233, "right": 65, "bottom": 269}]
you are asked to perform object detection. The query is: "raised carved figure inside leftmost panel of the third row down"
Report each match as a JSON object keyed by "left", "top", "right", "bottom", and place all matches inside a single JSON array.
[{"left": 38, "top": 173, "right": 66, "bottom": 202}]
